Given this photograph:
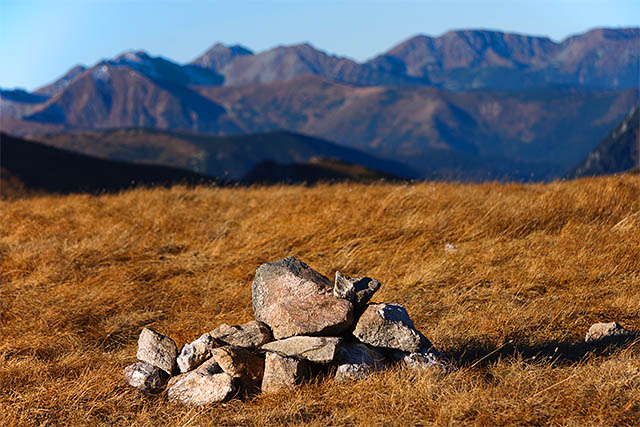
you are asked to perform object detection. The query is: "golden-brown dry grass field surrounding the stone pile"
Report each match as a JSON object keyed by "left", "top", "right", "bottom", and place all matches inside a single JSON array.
[{"left": 0, "top": 175, "right": 640, "bottom": 426}]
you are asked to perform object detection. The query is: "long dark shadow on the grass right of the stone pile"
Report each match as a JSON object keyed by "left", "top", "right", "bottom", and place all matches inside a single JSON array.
[{"left": 447, "top": 332, "right": 640, "bottom": 367}]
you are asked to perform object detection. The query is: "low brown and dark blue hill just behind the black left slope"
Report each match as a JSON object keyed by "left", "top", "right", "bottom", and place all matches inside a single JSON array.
[{"left": 30, "top": 129, "right": 419, "bottom": 180}]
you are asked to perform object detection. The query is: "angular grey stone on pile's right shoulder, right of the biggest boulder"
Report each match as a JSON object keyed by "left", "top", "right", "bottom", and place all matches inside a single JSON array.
[{"left": 353, "top": 304, "right": 431, "bottom": 352}]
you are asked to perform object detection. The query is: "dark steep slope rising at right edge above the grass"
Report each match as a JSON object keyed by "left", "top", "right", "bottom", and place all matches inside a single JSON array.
[{"left": 567, "top": 104, "right": 640, "bottom": 178}]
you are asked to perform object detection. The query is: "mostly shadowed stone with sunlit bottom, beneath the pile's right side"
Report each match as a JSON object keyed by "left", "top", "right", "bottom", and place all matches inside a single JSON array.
[{"left": 335, "top": 342, "right": 386, "bottom": 380}]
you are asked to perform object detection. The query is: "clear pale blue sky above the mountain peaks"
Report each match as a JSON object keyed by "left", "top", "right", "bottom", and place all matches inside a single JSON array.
[{"left": 0, "top": 0, "right": 640, "bottom": 90}]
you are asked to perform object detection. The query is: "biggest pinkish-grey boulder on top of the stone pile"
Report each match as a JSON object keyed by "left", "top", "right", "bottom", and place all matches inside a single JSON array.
[{"left": 251, "top": 257, "right": 353, "bottom": 339}]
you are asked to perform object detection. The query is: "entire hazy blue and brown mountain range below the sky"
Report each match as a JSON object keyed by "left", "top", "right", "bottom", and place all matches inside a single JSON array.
[{"left": 0, "top": 28, "right": 640, "bottom": 180}]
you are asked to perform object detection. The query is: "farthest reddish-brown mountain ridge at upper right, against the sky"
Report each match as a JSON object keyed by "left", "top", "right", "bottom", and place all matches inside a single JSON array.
[{"left": 369, "top": 28, "right": 640, "bottom": 90}]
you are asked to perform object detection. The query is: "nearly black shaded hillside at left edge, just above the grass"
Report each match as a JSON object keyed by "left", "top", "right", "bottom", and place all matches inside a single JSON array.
[{"left": 0, "top": 133, "right": 214, "bottom": 198}]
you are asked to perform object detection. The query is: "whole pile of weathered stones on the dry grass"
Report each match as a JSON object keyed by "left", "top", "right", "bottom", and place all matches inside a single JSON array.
[{"left": 124, "top": 257, "right": 449, "bottom": 405}]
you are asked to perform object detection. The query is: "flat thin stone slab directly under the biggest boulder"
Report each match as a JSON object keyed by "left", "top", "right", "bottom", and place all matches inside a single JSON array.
[{"left": 262, "top": 337, "right": 342, "bottom": 364}]
